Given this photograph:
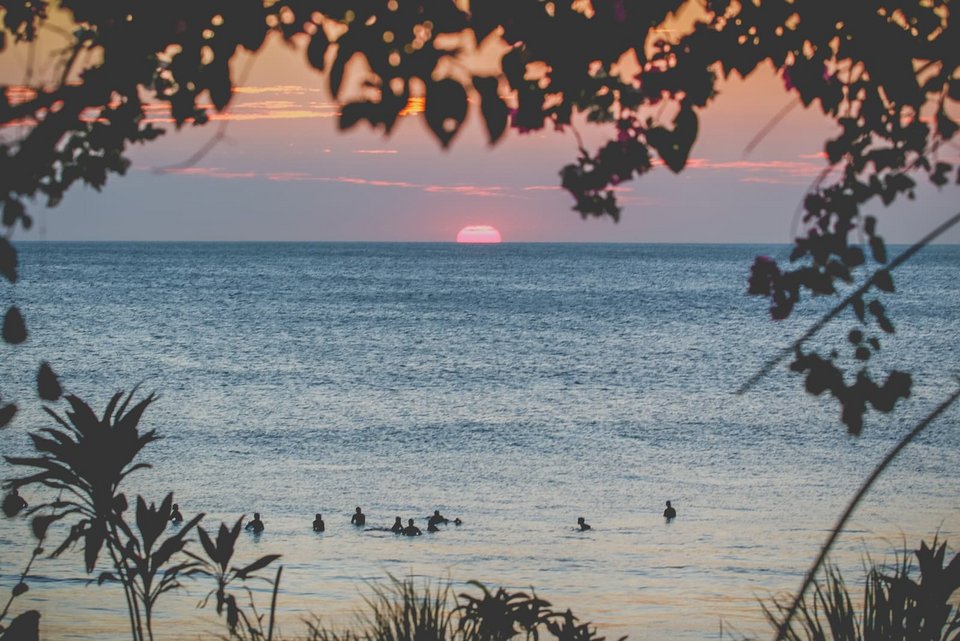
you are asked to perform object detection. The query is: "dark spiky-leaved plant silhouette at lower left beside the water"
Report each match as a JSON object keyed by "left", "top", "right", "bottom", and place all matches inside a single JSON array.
[{"left": 0, "top": 389, "right": 279, "bottom": 641}]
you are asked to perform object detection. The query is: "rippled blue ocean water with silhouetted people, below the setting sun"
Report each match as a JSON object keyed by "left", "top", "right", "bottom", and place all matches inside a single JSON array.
[{"left": 0, "top": 243, "right": 960, "bottom": 641}]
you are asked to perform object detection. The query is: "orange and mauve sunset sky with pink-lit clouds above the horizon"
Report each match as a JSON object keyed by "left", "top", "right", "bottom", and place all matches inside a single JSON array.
[{"left": 0, "top": 27, "right": 960, "bottom": 243}]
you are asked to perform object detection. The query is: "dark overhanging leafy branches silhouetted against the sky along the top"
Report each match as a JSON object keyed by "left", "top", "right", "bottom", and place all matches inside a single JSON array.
[{"left": 0, "top": 0, "right": 960, "bottom": 434}]
